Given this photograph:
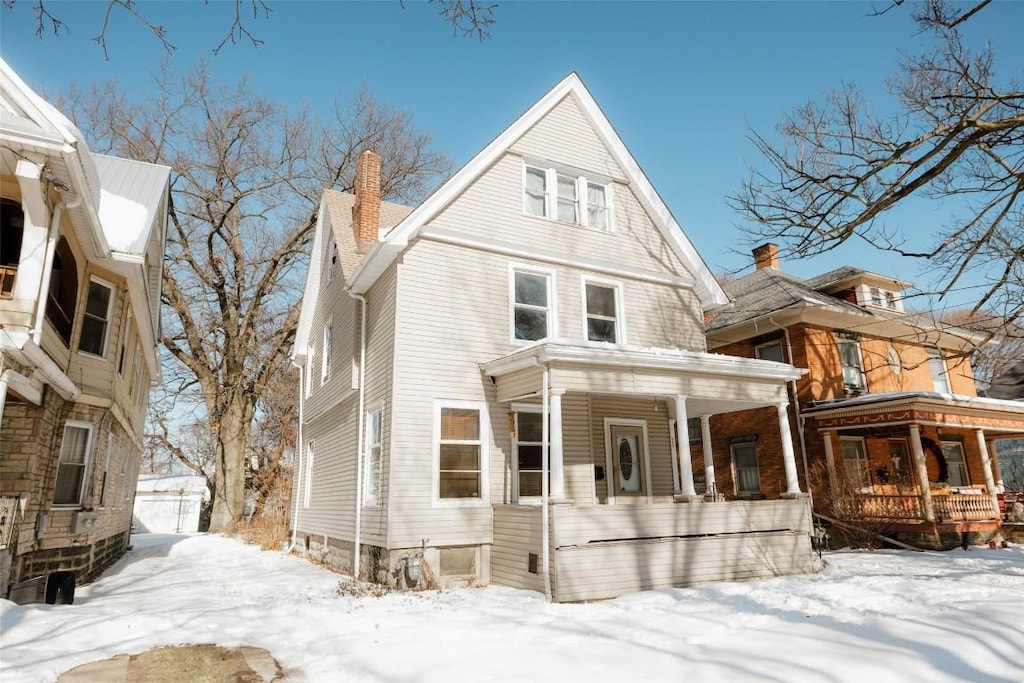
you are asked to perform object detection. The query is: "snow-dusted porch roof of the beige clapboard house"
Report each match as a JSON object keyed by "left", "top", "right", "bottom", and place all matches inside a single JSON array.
[{"left": 480, "top": 340, "right": 807, "bottom": 415}]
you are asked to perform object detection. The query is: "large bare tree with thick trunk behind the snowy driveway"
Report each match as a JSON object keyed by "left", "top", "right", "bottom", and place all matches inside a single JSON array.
[{"left": 60, "top": 62, "right": 451, "bottom": 531}]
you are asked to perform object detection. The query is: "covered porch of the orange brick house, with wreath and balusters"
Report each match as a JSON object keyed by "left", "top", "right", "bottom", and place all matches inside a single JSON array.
[{"left": 805, "top": 392, "right": 1024, "bottom": 536}]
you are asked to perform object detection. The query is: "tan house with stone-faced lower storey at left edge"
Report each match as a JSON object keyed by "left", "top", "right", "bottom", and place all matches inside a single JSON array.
[{"left": 0, "top": 60, "right": 170, "bottom": 601}]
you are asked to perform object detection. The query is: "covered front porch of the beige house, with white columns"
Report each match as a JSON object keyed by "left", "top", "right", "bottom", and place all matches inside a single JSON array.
[{"left": 483, "top": 343, "right": 814, "bottom": 601}]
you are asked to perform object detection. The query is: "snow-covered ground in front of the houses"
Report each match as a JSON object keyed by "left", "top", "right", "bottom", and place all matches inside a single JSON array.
[{"left": 0, "top": 536, "right": 1024, "bottom": 683}]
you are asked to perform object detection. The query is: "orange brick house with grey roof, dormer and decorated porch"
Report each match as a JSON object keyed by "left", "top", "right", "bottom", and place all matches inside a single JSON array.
[{"left": 706, "top": 245, "right": 1024, "bottom": 544}]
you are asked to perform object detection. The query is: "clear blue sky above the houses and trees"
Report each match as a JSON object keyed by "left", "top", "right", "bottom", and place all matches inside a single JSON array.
[{"left": 0, "top": 0, "right": 1024, "bottom": 304}]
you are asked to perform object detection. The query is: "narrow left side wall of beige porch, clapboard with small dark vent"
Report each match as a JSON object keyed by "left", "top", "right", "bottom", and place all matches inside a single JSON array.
[{"left": 490, "top": 505, "right": 544, "bottom": 591}]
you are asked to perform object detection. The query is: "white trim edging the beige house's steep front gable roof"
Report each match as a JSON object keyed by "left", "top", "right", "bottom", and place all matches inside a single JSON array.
[{"left": 347, "top": 73, "right": 728, "bottom": 308}]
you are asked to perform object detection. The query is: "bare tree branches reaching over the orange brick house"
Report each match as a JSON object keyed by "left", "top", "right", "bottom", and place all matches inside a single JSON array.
[{"left": 730, "top": 0, "right": 1024, "bottom": 325}]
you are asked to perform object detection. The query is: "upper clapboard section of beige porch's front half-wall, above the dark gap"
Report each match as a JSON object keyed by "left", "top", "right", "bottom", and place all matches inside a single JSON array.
[{"left": 553, "top": 498, "right": 810, "bottom": 547}]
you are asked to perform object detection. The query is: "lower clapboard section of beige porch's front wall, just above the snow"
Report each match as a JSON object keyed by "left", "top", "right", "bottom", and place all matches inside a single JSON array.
[{"left": 554, "top": 531, "right": 815, "bottom": 602}]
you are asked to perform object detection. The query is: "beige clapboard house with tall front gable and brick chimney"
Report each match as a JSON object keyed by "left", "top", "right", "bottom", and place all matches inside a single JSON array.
[{"left": 293, "top": 74, "right": 814, "bottom": 601}]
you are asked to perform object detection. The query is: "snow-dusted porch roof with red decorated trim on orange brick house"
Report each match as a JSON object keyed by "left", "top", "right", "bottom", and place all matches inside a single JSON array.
[{"left": 803, "top": 391, "right": 1024, "bottom": 436}]
